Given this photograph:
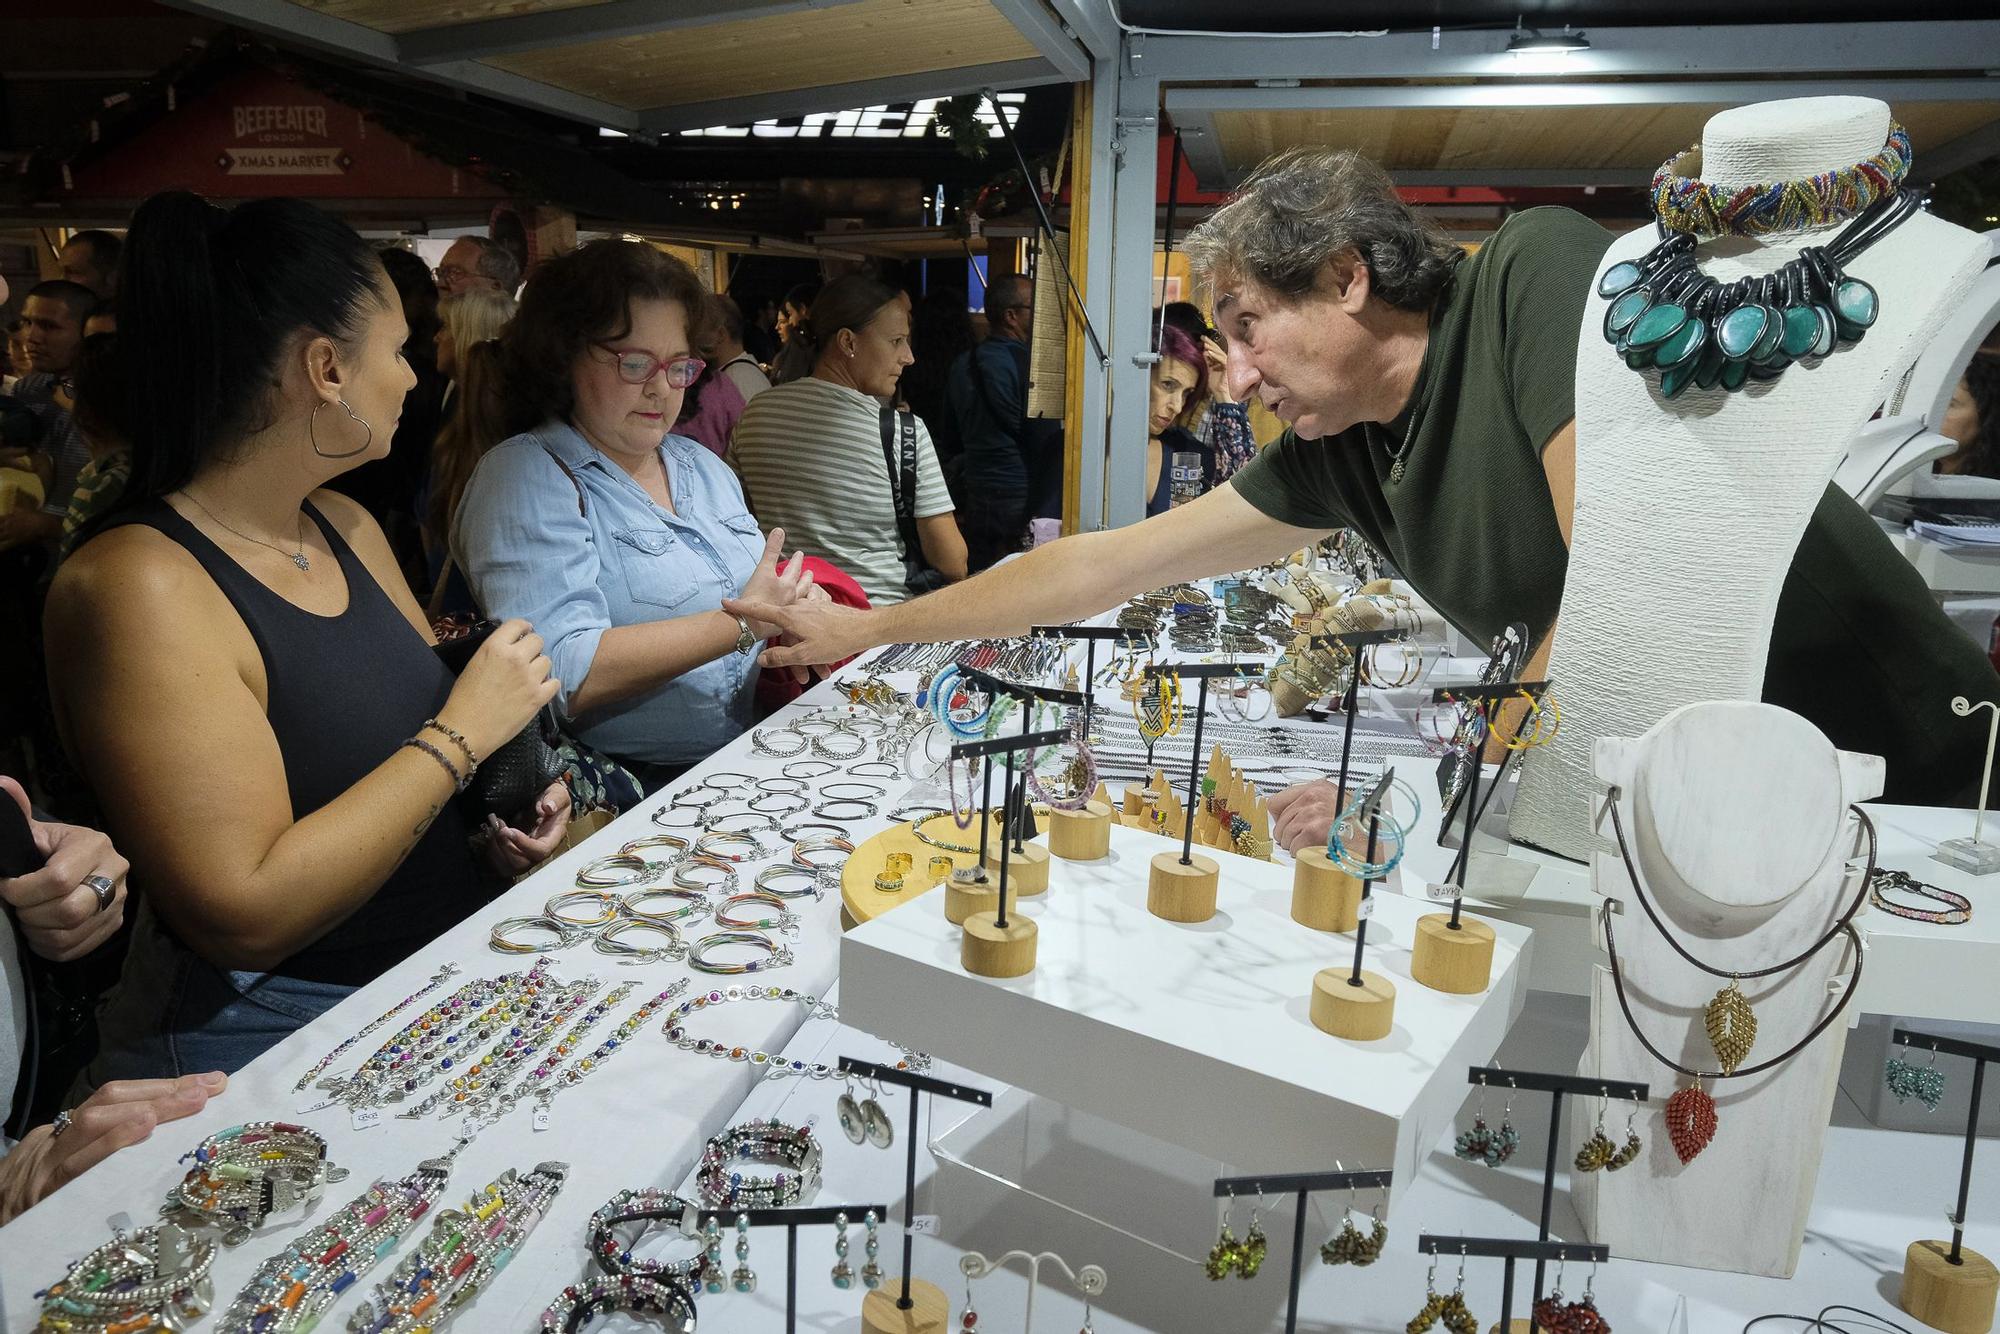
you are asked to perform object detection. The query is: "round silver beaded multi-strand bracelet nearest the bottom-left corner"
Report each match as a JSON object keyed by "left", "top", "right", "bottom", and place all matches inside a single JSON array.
[{"left": 34, "top": 1222, "right": 216, "bottom": 1334}]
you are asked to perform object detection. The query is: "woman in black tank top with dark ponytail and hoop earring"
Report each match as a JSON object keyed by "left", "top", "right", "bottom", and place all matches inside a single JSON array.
[{"left": 48, "top": 192, "right": 570, "bottom": 1082}]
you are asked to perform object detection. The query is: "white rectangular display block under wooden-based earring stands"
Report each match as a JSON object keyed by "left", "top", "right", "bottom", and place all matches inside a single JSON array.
[{"left": 840, "top": 828, "right": 1528, "bottom": 1224}]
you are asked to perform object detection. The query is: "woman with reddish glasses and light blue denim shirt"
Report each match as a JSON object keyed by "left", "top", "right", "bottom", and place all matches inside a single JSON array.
[{"left": 452, "top": 240, "right": 812, "bottom": 788}]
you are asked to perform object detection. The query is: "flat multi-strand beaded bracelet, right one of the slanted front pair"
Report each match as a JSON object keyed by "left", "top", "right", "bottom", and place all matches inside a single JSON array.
[{"left": 348, "top": 1162, "right": 570, "bottom": 1334}]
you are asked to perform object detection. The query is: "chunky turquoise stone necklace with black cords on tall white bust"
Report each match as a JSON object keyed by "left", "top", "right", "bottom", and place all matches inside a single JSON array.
[{"left": 1598, "top": 190, "right": 1918, "bottom": 398}]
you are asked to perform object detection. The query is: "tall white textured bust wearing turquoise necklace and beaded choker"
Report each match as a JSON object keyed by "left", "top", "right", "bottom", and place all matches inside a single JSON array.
[{"left": 1508, "top": 98, "right": 1990, "bottom": 860}]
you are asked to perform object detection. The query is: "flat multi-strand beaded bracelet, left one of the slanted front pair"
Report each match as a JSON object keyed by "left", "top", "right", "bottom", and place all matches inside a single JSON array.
[{"left": 218, "top": 1156, "right": 452, "bottom": 1334}]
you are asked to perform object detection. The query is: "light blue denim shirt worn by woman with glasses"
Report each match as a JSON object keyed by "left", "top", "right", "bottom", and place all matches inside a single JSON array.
[{"left": 452, "top": 422, "right": 764, "bottom": 764}]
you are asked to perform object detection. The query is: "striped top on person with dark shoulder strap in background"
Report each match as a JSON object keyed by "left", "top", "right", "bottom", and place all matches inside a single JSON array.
[{"left": 728, "top": 376, "right": 952, "bottom": 606}]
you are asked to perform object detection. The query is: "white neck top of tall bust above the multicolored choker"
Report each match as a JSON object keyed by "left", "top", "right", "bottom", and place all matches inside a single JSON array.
[{"left": 1700, "top": 98, "right": 1890, "bottom": 186}]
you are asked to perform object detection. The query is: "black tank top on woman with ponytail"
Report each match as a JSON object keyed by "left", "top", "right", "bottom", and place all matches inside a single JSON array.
[{"left": 128, "top": 500, "right": 486, "bottom": 986}]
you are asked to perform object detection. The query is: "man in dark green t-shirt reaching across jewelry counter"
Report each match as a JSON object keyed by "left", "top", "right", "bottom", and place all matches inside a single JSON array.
[{"left": 724, "top": 150, "right": 2000, "bottom": 848}]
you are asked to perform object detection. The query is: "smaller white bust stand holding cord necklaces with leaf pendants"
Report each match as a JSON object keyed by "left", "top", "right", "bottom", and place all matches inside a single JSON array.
[{"left": 1570, "top": 702, "right": 1882, "bottom": 1278}]
